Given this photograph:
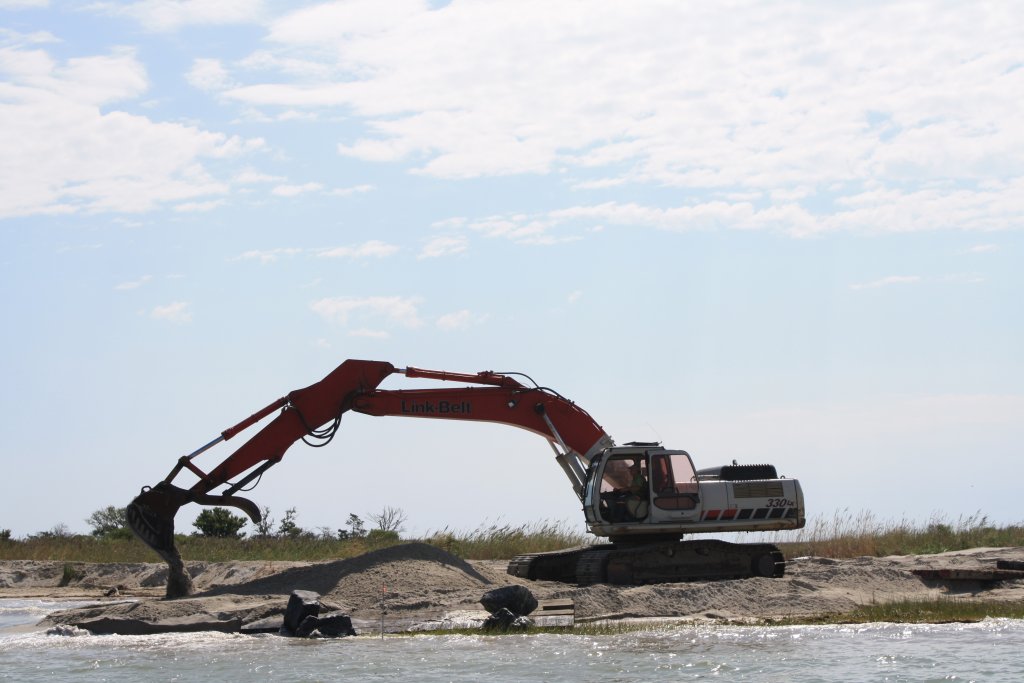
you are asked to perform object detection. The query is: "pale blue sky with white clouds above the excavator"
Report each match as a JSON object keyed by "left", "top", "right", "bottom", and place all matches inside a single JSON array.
[{"left": 0, "top": 0, "right": 1024, "bottom": 537}]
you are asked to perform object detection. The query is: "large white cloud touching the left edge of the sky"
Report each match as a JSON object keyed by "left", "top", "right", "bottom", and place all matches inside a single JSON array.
[{"left": 0, "top": 48, "right": 262, "bottom": 218}]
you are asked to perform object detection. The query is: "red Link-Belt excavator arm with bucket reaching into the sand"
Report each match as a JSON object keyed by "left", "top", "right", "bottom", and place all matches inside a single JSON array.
[{"left": 127, "top": 359, "right": 614, "bottom": 597}]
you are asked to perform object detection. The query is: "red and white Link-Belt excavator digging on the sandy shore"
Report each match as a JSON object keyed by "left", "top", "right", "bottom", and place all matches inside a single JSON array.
[{"left": 126, "top": 359, "right": 805, "bottom": 598}]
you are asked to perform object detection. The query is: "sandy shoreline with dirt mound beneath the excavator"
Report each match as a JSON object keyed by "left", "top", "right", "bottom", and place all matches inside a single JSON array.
[{"left": 0, "top": 543, "right": 1024, "bottom": 632}]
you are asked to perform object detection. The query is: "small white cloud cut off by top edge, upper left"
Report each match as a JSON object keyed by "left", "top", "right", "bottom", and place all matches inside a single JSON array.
[{"left": 90, "top": 0, "right": 265, "bottom": 31}]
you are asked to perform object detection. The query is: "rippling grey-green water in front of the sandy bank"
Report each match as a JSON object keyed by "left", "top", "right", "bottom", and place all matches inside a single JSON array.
[{"left": 0, "top": 600, "right": 1024, "bottom": 683}]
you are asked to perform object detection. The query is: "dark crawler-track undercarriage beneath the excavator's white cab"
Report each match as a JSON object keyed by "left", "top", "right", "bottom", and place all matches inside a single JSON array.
[{"left": 508, "top": 541, "right": 785, "bottom": 586}]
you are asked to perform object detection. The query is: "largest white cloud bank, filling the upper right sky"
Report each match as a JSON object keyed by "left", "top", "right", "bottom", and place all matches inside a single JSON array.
[{"left": 218, "top": 0, "right": 1024, "bottom": 236}]
